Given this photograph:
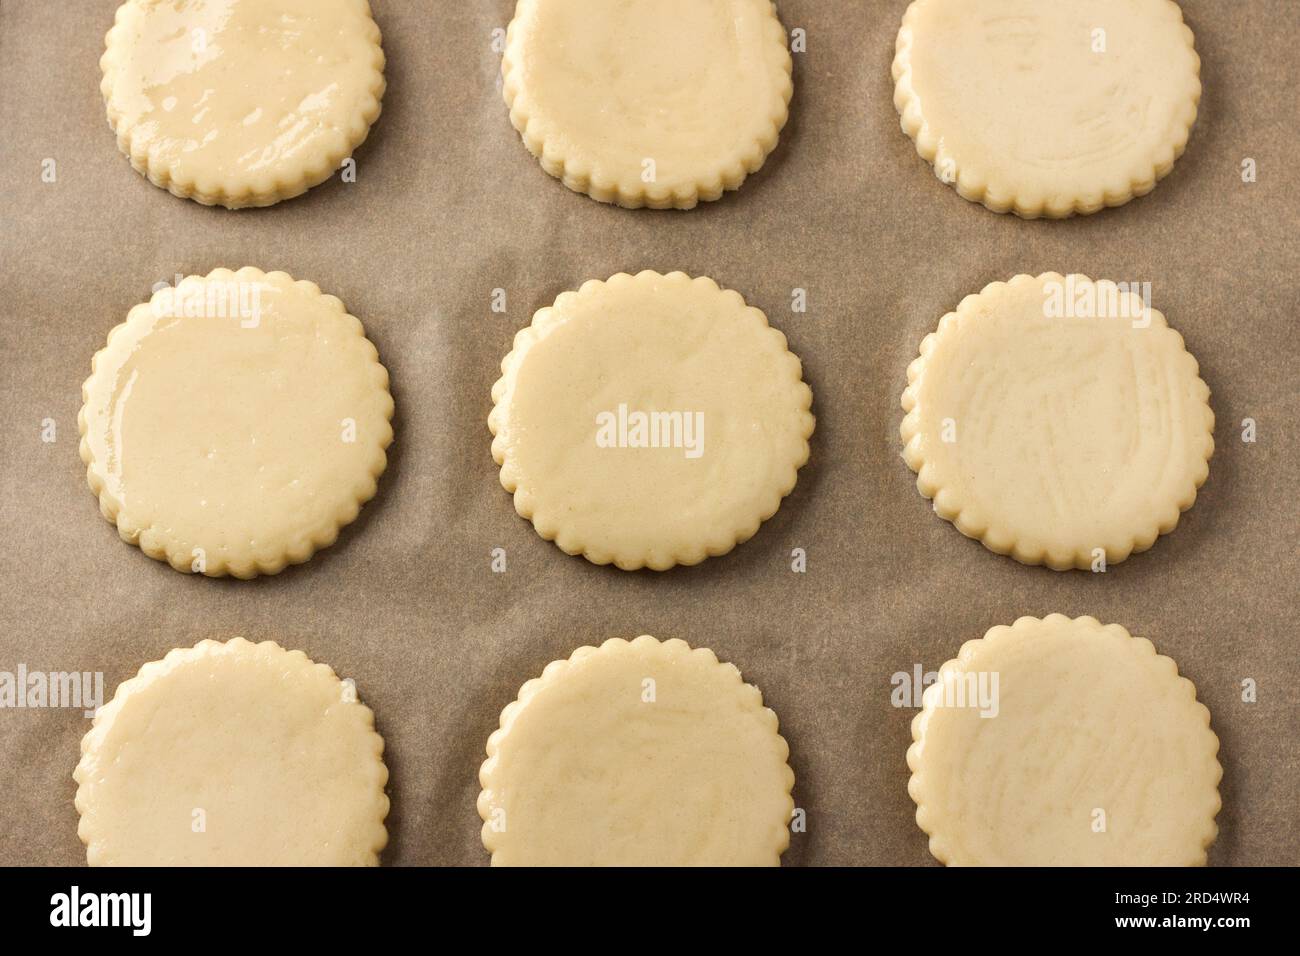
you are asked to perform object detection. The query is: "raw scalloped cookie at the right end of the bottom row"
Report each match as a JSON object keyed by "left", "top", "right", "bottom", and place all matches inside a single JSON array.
[{"left": 907, "top": 614, "right": 1223, "bottom": 866}]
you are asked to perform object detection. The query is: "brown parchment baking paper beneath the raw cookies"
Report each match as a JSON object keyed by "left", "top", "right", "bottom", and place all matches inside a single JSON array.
[{"left": 0, "top": 0, "right": 1300, "bottom": 865}]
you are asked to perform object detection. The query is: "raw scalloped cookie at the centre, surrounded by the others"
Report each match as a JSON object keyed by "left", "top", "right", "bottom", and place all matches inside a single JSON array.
[{"left": 488, "top": 272, "right": 814, "bottom": 571}]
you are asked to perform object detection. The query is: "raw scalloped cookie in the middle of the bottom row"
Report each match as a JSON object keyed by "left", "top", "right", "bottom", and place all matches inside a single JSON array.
[{"left": 478, "top": 636, "right": 794, "bottom": 866}]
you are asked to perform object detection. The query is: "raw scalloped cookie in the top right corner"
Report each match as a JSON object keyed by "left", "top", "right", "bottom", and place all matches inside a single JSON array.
[{"left": 893, "top": 0, "right": 1201, "bottom": 219}]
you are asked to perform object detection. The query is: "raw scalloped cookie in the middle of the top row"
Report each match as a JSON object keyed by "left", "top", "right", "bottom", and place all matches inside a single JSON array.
[{"left": 501, "top": 0, "right": 793, "bottom": 209}]
